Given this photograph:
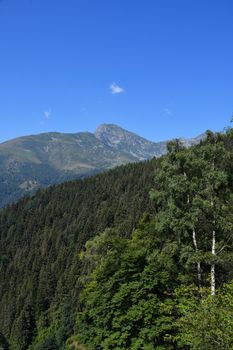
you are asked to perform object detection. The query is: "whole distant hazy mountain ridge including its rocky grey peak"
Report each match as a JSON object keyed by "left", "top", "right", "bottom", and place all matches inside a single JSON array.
[{"left": 0, "top": 124, "right": 200, "bottom": 207}]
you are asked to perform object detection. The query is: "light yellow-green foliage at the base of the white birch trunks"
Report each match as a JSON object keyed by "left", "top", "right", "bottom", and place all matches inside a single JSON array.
[{"left": 176, "top": 283, "right": 233, "bottom": 350}]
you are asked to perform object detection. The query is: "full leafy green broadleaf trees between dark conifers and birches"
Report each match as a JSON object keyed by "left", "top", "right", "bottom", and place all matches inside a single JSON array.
[{"left": 76, "top": 224, "right": 177, "bottom": 350}]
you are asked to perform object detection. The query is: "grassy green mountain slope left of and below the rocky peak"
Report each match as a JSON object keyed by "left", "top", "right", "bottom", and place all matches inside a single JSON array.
[{"left": 0, "top": 129, "right": 138, "bottom": 207}]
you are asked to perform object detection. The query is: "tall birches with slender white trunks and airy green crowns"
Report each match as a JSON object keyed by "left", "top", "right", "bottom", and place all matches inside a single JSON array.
[{"left": 152, "top": 132, "right": 233, "bottom": 295}]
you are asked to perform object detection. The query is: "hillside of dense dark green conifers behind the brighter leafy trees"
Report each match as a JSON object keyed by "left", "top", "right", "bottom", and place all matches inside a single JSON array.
[{"left": 0, "top": 160, "right": 157, "bottom": 349}]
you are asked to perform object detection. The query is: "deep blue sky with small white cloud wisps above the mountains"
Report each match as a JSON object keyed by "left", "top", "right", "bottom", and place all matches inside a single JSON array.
[{"left": 0, "top": 0, "right": 233, "bottom": 141}]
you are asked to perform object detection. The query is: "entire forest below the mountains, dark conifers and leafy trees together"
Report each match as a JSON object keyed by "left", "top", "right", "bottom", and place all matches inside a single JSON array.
[{"left": 0, "top": 129, "right": 233, "bottom": 350}]
